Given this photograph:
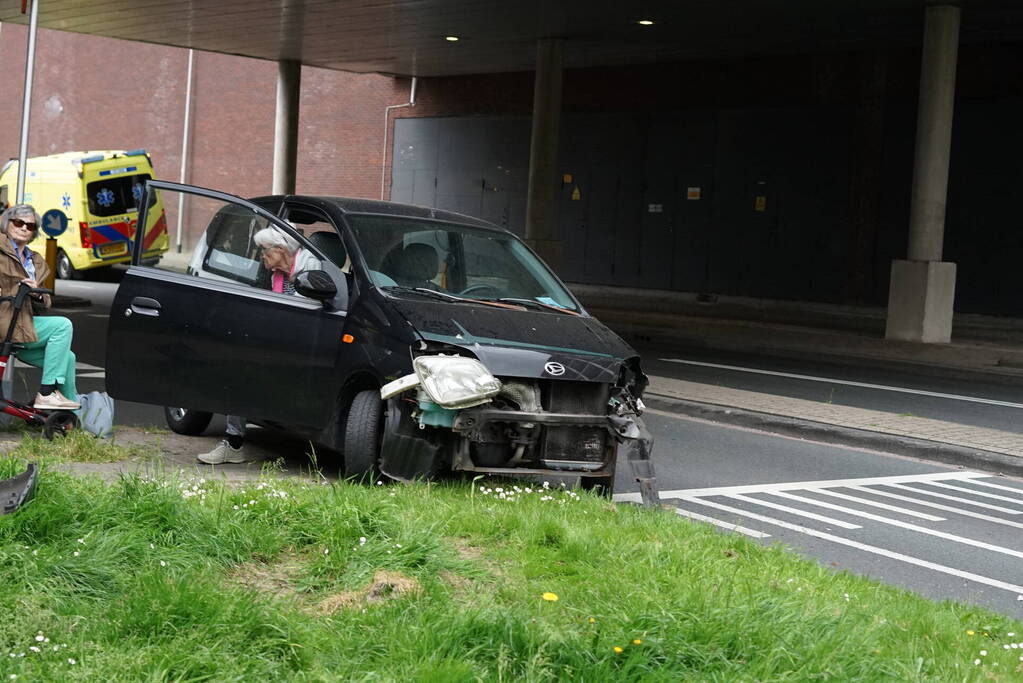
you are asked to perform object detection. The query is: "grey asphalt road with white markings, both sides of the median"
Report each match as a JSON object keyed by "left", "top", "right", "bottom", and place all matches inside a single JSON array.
[{"left": 21, "top": 281, "right": 1023, "bottom": 619}]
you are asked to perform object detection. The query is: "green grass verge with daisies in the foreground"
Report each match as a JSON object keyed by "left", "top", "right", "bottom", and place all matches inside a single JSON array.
[{"left": 0, "top": 457, "right": 1023, "bottom": 682}]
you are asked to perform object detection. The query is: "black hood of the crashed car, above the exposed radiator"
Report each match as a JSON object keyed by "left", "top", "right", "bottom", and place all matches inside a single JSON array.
[{"left": 391, "top": 300, "right": 636, "bottom": 382}]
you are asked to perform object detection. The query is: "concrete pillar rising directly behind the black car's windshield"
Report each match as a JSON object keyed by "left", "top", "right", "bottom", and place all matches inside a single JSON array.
[{"left": 526, "top": 38, "right": 564, "bottom": 270}]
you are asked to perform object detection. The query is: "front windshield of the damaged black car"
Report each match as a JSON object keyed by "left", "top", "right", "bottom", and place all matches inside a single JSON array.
[{"left": 348, "top": 214, "right": 578, "bottom": 311}]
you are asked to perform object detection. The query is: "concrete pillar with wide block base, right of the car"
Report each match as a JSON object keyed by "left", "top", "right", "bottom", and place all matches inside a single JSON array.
[{"left": 885, "top": 5, "right": 960, "bottom": 344}]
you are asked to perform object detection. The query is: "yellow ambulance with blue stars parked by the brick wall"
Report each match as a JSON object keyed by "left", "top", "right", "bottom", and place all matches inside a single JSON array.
[{"left": 0, "top": 149, "right": 170, "bottom": 279}]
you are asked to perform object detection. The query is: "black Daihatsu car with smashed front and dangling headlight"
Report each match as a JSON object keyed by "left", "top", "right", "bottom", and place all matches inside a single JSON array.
[{"left": 106, "top": 181, "right": 656, "bottom": 502}]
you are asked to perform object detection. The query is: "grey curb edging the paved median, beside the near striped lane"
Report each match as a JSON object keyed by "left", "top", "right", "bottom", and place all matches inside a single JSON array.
[{"left": 643, "top": 393, "right": 1023, "bottom": 476}]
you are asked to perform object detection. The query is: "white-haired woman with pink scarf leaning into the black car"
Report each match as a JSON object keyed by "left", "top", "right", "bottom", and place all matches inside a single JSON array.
[{"left": 195, "top": 227, "right": 322, "bottom": 465}]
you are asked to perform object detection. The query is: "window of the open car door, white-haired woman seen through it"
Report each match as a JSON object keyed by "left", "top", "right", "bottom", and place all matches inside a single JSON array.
[{"left": 140, "top": 189, "right": 322, "bottom": 294}]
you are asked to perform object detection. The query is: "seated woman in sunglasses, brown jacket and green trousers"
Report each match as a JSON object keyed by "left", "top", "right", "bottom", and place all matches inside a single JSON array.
[{"left": 0, "top": 203, "right": 82, "bottom": 410}]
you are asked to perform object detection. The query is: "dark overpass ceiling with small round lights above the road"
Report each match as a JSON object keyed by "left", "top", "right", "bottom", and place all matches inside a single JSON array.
[{"left": 0, "top": 0, "right": 1023, "bottom": 77}]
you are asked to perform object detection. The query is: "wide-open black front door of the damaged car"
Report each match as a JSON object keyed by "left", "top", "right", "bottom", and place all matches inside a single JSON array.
[{"left": 106, "top": 181, "right": 348, "bottom": 427}]
